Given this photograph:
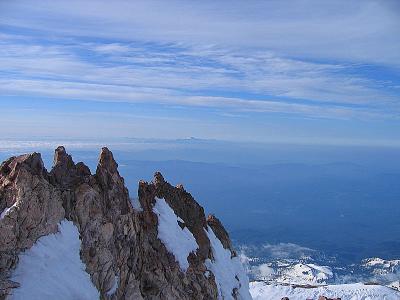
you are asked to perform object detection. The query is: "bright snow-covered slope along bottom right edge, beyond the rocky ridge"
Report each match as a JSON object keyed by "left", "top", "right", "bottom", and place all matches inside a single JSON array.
[{"left": 250, "top": 282, "right": 400, "bottom": 300}]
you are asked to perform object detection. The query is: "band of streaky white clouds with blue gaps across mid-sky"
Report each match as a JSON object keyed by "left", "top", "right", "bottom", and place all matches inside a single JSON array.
[{"left": 0, "top": 35, "right": 399, "bottom": 118}]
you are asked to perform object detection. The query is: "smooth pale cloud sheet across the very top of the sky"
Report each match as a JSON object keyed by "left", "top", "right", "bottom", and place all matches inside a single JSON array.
[{"left": 1, "top": 0, "right": 400, "bottom": 65}]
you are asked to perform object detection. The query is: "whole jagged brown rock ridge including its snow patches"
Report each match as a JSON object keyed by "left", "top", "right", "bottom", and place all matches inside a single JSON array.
[{"left": 0, "top": 146, "right": 251, "bottom": 299}]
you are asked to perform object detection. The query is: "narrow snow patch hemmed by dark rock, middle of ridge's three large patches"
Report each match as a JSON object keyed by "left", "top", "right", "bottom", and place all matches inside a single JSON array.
[{"left": 153, "top": 198, "right": 199, "bottom": 272}]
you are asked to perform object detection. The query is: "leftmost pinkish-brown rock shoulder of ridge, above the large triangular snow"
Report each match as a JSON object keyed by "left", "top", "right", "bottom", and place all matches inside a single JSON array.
[{"left": 0, "top": 153, "right": 65, "bottom": 297}]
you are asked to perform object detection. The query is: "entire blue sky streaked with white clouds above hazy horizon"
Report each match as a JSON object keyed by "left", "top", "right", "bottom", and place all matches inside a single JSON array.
[{"left": 0, "top": 0, "right": 400, "bottom": 147}]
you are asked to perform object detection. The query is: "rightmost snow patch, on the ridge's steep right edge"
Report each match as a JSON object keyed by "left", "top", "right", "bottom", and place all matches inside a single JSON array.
[{"left": 206, "top": 227, "right": 252, "bottom": 300}]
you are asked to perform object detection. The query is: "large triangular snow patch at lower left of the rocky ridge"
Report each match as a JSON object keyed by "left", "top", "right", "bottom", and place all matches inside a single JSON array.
[{"left": 9, "top": 220, "right": 100, "bottom": 300}]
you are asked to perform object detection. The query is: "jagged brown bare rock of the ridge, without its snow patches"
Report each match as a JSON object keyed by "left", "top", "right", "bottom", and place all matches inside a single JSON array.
[{"left": 0, "top": 147, "right": 241, "bottom": 299}]
